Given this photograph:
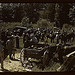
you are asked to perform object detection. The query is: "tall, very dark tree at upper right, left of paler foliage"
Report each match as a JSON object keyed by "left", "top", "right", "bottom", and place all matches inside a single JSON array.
[{"left": 55, "top": 3, "right": 71, "bottom": 28}]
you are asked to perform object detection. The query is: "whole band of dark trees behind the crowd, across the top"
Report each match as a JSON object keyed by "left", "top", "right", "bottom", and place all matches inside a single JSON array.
[{"left": 0, "top": 3, "right": 74, "bottom": 28}]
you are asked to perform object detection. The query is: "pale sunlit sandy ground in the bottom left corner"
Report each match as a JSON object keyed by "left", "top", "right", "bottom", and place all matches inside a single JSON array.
[{"left": 0, "top": 49, "right": 23, "bottom": 72}]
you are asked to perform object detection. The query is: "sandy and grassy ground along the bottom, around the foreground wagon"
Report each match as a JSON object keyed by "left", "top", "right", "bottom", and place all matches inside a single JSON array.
[{"left": 0, "top": 51, "right": 60, "bottom": 72}]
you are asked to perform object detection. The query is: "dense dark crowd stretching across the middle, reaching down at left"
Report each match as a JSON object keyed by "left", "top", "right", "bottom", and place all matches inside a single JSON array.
[{"left": 0, "top": 27, "right": 75, "bottom": 68}]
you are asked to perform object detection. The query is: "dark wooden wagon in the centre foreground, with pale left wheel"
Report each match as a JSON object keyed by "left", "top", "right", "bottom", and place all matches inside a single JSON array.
[{"left": 20, "top": 44, "right": 56, "bottom": 66}]
